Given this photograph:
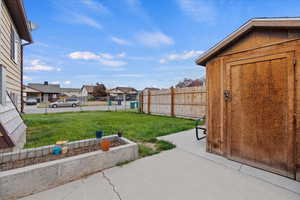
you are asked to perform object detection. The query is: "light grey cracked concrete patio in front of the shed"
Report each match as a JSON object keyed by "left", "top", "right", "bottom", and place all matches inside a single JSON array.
[{"left": 22, "top": 130, "right": 300, "bottom": 200}]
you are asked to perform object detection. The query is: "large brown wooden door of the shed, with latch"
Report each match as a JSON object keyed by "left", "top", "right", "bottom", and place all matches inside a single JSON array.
[{"left": 224, "top": 52, "right": 295, "bottom": 178}]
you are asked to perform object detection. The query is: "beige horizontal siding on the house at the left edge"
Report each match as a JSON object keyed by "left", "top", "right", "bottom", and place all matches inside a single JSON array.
[{"left": 0, "top": 0, "right": 21, "bottom": 108}]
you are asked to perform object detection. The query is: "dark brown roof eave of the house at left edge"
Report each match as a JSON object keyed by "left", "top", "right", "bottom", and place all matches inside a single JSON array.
[{"left": 4, "top": 0, "right": 32, "bottom": 42}]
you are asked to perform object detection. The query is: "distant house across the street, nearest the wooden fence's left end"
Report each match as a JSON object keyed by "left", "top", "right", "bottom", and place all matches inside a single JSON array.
[{"left": 108, "top": 87, "right": 138, "bottom": 100}]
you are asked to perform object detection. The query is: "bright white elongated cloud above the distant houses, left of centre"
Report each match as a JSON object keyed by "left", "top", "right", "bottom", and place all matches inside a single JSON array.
[{"left": 69, "top": 51, "right": 127, "bottom": 67}]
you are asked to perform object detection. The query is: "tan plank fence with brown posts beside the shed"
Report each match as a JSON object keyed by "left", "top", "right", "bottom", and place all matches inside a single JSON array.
[{"left": 140, "top": 87, "right": 207, "bottom": 119}]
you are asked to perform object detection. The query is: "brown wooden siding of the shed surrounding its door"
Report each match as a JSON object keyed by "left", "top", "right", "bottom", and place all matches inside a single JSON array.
[{"left": 206, "top": 30, "right": 300, "bottom": 181}]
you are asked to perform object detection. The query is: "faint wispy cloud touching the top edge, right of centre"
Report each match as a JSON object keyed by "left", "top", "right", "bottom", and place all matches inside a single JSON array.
[{"left": 177, "top": 0, "right": 216, "bottom": 22}]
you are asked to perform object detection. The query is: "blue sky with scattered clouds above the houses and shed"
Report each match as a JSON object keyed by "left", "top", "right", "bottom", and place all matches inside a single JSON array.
[{"left": 24, "top": 0, "right": 300, "bottom": 89}]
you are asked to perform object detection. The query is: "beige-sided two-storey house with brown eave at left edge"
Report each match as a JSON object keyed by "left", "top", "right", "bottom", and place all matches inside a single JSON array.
[{"left": 0, "top": 0, "right": 32, "bottom": 152}]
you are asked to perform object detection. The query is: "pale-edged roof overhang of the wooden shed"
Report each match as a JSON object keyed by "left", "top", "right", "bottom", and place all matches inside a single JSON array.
[{"left": 196, "top": 17, "right": 300, "bottom": 66}]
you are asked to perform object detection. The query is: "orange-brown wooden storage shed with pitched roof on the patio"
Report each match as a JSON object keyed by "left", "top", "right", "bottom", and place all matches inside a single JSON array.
[{"left": 196, "top": 18, "right": 300, "bottom": 181}]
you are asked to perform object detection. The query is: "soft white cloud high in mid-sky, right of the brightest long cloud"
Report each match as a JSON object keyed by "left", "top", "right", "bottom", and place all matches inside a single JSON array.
[{"left": 137, "top": 32, "right": 174, "bottom": 47}]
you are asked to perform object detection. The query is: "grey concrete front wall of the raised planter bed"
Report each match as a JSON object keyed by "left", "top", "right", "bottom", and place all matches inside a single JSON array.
[{"left": 0, "top": 136, "right": 138, "bottom": 200}]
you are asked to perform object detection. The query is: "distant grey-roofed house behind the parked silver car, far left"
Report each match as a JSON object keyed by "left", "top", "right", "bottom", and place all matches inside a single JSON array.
[{"left": 27, "top": 81, "right": 61, "bottom": 102}]
